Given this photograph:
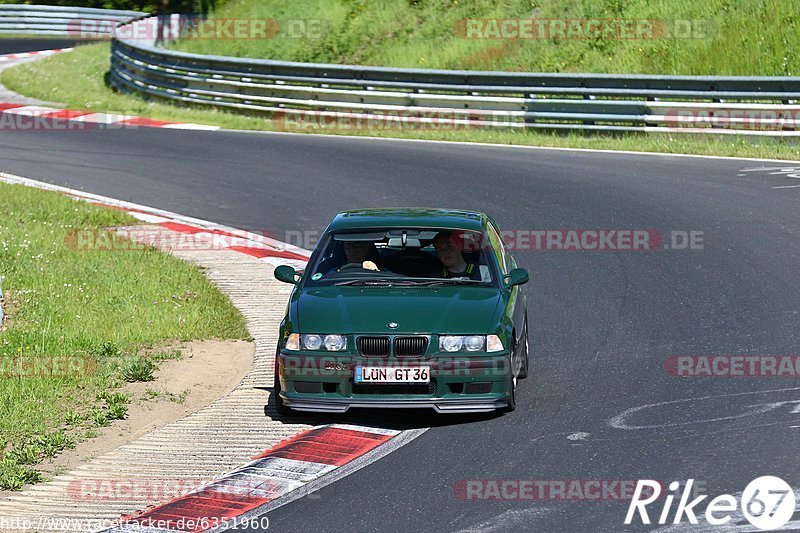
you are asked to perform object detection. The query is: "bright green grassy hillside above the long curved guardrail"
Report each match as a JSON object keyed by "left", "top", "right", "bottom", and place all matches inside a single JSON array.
[{"left": 172, "top": 0, "right": 800, "bottom": 76}]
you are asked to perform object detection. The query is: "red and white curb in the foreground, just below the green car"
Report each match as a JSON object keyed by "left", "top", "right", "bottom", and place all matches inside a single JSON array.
[{"left": 101, "top": 424, "right": 401, "bottom": 533}]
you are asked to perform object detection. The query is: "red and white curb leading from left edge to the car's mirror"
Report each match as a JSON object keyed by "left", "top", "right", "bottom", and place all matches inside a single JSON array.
[{"left": 0, "top": 172, "right": 311, "bottom": 269}]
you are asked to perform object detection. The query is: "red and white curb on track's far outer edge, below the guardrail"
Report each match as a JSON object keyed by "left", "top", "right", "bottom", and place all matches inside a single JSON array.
[{"left": 0, "top": 102, "right": 220, "bottom": 131}]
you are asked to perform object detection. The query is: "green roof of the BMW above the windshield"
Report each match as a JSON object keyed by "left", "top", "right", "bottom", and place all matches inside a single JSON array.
[{"left": 328, "top": 207, "right": 488, "bottom": 231}]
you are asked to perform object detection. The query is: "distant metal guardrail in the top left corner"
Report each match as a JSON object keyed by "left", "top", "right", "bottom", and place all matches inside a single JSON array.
[{"left": 0, "top": 4, "right": 142, "bottom": 38}]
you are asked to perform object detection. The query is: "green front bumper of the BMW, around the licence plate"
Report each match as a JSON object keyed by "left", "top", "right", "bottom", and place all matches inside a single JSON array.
[{"left": 277, "top": 353, "right": 511, "bottom": 413}]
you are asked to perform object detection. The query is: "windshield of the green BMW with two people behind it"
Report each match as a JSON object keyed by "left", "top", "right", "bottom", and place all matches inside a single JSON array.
[{"left": 306, "top": 228, "right": 497, "bottom": 287}]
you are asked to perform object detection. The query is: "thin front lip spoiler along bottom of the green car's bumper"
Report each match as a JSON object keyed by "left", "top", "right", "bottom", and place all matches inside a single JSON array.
[{"left": 281, "top": 394, "right": 508, "bottom": 413}]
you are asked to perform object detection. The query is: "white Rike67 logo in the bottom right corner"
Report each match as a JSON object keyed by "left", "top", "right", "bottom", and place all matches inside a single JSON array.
[{"left": 625, "top": 476, "right": 796, "bottom": 530}]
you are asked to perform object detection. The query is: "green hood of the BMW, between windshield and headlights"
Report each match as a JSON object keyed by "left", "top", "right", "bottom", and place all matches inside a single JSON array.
[{"left": 296, "top": 287, "right": 502, "bottom": 334}]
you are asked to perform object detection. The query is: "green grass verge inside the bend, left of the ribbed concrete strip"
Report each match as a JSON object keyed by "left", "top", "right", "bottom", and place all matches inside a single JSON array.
[{"left": 0, "top": 183, "right": 247, "bottom": 489}]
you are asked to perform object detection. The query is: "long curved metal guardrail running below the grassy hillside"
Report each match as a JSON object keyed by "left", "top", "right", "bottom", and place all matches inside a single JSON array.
[{"left": 56, "top": 18, "right": 800, "bottom": 136}]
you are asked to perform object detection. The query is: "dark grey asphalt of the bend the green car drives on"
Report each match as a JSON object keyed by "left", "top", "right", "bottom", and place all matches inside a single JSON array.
[{"left": 0, "top": 124, "right": 800, "bottom": 532}]
